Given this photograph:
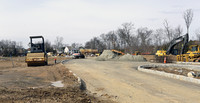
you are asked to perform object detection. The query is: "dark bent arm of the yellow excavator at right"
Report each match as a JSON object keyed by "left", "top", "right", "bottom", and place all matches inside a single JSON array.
[{"left": 166, "top": 33, "right": 189, "bottom": 55}]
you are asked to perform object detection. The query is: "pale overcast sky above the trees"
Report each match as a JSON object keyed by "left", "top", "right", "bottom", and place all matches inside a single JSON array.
[{"left": 0, "top": 0, "right": 200, "bottom": 47}]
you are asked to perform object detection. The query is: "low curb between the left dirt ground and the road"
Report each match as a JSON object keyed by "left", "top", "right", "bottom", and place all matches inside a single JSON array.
[{"left": 61, "top": 60, "right": 86, "bottom": 90}]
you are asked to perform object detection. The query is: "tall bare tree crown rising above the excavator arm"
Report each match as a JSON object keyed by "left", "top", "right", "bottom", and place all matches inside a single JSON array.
[{"left": 183, "top": 9, "right": 193, "bottom": 34}]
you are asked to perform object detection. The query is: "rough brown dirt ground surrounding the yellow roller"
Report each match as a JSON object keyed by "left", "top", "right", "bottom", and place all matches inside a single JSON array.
[{"left": 0, "top": 57, "right": 112, "bottom": 103}]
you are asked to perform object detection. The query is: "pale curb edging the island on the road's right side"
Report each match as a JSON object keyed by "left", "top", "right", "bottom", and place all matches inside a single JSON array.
[{"left": 138, "top": 65, "right": 200, "bottom": 84}]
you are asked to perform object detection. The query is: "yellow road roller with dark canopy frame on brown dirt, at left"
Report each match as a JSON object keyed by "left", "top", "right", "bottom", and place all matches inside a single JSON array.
[{"left": 25, "top": 36, "right": 48, "bottom": 66}]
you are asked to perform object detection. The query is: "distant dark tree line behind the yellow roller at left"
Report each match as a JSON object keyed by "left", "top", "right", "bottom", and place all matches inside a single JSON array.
[{"left": 0, "top": 36, "right": 83, "bottom": 57}]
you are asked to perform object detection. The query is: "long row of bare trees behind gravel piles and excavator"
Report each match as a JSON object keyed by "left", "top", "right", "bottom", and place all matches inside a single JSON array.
[{"left": 85, "top": 9, "right": 195, "bottom": 54}]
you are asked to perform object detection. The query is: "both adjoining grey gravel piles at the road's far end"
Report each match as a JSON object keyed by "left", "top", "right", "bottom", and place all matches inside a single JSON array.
[{"left": 96, "top": 50, "right": 146, "bottom": 62}]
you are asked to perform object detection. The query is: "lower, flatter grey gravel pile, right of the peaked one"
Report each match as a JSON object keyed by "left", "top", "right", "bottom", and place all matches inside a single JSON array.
[{"left": 119, "top": 54, "right": 146, "bottom": 62}]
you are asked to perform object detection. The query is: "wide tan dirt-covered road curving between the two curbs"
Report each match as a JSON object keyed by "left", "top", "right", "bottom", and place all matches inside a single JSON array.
[{"left": 65, "top": 59, "right": 200, "bottom": 103}]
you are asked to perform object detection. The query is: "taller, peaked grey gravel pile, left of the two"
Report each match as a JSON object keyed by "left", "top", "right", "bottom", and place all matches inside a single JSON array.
[{"left": 96, "top": 50, "right": 118, "bottom": 61}]
